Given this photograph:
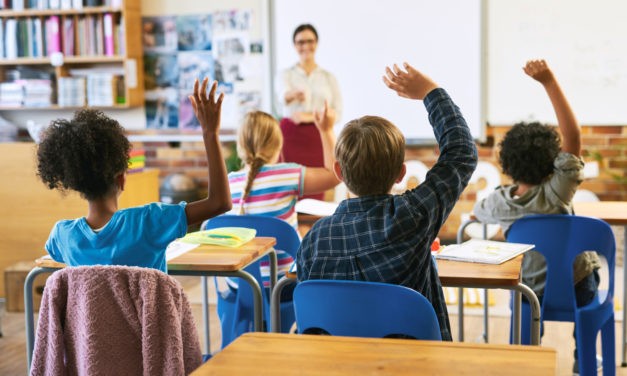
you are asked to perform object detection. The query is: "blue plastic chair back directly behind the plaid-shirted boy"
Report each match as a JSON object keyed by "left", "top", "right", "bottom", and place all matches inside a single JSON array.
[{"left": 294, "top": 280, "right": 442, "bottom": 340}]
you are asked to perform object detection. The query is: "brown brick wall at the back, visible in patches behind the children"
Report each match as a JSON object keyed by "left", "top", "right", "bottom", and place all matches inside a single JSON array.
[{"left": 135, "top": 126, "right": 627, "bottom": 241}]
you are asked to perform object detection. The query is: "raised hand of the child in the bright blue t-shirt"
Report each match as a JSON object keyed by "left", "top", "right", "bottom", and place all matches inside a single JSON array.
[{"left": 189, "top": 77, "right": 224, "bottom": 134}]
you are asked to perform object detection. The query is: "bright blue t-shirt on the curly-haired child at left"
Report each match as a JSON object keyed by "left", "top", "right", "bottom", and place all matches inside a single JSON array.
[{"left": 46, "top": 202, "right": 187, "bottom": 272}]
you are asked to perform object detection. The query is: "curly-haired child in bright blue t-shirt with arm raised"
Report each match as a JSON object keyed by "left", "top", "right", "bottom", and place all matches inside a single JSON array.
[{"left": 37, "top": 78, "right": 231, "bottom": 272}]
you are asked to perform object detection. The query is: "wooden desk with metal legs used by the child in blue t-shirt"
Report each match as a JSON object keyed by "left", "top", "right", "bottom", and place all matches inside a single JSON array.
[{"left": 24, "top": 237, "right": 277, "bottom": 369}]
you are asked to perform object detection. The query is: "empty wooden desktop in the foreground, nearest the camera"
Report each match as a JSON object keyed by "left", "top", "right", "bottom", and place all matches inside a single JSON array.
[{"left": 192, "top": 333, "right": 557, "bottom": 376}]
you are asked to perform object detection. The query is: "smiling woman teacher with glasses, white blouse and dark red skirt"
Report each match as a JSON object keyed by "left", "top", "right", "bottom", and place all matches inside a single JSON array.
[{"left": 277, "top": 24, "right": 342, "bottom": 200}]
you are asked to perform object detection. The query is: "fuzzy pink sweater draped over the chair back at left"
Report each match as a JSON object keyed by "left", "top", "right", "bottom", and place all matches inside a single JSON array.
[{"left": 31, "top": 266, "right": 201, "bottom": 375}]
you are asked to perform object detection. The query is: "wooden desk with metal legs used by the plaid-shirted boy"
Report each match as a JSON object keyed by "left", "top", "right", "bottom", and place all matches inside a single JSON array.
[{"left": 270, "top": 255, "right": 540, "bottom": 345}]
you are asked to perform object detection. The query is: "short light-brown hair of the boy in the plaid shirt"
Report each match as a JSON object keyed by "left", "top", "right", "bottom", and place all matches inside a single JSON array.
[{"left": 335, "top": 116, "right": 405, "bottom": 196}]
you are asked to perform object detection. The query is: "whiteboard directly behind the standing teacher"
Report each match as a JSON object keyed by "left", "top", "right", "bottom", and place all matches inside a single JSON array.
[{"left": 270, "top": 0, "right": 485, "bottom": 143}]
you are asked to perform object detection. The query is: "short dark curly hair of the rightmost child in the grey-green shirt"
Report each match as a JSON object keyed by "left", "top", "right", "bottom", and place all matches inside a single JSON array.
[{"left": 499, "top": 122, "right": 561, "bottom": 185}]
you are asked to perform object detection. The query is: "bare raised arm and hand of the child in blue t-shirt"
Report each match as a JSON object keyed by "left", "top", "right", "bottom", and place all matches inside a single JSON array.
[{"left": 185, "top": 78, "right": 236, "bottom": 225}]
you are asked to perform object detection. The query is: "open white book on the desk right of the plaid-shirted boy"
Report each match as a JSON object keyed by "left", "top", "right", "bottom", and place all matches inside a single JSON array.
[{"left": 435, "top": 239, "right": 534, "bottom": 264}]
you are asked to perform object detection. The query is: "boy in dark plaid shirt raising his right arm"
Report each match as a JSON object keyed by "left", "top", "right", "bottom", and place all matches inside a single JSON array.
[{"left": 297, "top": 63, "right": 477, "bottom": 340}]
